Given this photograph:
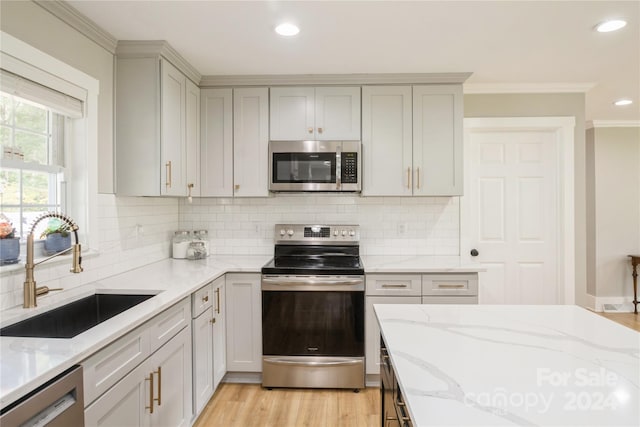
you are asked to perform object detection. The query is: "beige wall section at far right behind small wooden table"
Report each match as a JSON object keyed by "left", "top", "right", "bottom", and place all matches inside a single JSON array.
[{"left": 588, "top": 127, "right": 640, "bottom": 300}]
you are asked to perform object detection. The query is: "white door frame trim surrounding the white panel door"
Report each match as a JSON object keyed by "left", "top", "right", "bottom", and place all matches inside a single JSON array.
[{"left": 460, "top": 117, "right": 576, "bottom": 304}]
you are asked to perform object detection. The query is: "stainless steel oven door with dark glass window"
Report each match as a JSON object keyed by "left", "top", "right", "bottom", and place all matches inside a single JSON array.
[{"left": 262, "top": 275, "right": 364, "bottom": 357}]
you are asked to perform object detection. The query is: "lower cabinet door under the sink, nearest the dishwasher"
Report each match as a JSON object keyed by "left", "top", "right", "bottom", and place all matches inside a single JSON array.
[{"left": 84, "top": 362, "right": 151, "bottom": 427}]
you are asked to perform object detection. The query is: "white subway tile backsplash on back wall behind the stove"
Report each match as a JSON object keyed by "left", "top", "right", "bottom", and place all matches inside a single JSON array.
[{"left": 180, "top": 194, "right": 460, "bottom": 255}]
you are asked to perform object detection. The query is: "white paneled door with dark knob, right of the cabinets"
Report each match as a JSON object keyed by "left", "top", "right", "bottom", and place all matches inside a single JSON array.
[{"left": 467, "top": 130, "right": 562, "bottom": 304}]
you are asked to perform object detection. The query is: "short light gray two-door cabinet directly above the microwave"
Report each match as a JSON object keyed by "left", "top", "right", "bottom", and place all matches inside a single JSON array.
[{"left": 269, "top": 87, "right": 360, "bottom": 141}]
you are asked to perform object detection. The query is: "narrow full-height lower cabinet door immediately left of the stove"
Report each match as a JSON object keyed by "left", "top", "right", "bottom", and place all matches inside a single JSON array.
[{"left": 226, "top": 273, "right": 262, "bottom": 372}]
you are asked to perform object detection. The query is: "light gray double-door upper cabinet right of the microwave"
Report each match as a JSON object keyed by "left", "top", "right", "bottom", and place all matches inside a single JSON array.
[{"left": 362, "top": 85, "right": 463, "bottom": 196}]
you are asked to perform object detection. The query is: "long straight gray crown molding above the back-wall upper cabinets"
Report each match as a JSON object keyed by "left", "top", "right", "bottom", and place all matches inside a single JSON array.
[{"left": 200, "top": 73, "right": 471, "bottom": 88}]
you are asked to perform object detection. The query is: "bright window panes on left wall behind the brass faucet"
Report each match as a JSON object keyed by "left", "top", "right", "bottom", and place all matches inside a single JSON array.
[{"left": 0, "top": 92, "right": 65, "bottom": 237}]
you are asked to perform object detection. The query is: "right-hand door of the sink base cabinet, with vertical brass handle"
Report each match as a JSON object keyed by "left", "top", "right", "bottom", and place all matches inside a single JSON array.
[{"left": 149, "top": 327, "right": 193, "bottom": 427}]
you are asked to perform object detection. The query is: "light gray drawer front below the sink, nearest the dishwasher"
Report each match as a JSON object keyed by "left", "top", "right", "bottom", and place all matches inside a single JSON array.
[{"left": 82, "top": 326, "right": 151, "bottom": 407}]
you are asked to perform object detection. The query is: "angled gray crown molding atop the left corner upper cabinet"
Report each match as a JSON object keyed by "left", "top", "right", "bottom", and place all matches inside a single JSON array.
[{"left": 115, "top": 40, "right": 202, "bottom": 85}]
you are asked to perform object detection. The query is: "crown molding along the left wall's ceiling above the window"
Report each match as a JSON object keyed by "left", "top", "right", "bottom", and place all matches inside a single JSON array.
[{"left": 33, "top": 0, "right": 118, "bottom": 53}]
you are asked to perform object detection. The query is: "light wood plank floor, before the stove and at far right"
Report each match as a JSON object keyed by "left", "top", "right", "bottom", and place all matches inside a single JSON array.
[{"left": 194, "top": 313, "right": 640, "bottom": 427}]
